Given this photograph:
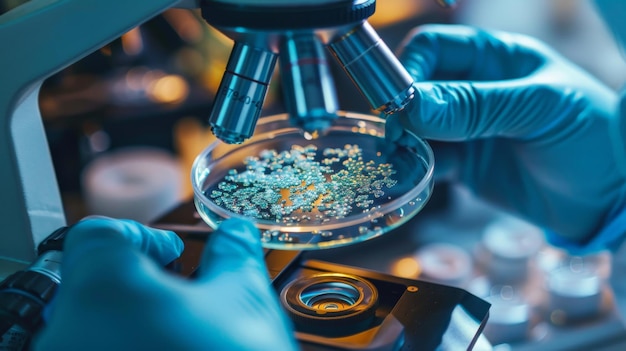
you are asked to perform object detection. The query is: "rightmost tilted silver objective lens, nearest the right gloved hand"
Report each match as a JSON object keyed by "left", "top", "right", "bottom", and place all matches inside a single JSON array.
[{"left": 328, "top": 21, "right": 415, "bottom": 114}]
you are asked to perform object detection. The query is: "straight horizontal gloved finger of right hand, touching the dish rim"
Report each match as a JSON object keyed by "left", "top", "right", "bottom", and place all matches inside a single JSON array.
[{"left": 390, "top": 79, "right": 560, "bottom": 141}]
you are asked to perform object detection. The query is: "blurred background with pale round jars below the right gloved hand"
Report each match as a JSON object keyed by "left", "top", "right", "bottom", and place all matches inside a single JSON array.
[{"left": 304, "top": 186, "right": 626, "bottom": 351}]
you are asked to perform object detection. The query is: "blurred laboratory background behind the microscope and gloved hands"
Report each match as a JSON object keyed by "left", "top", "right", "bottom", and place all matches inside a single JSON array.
[{"left": 0, "top": 0, "right": 626, "bottom": 351}]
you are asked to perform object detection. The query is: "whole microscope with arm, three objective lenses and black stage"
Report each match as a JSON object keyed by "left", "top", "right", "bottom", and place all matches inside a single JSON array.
[{"left": 0, "top": 0, "right": 489, "bottom": 350}]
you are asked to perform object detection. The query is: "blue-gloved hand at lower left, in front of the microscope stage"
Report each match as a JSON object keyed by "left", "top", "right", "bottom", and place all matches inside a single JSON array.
[{"left": 34, "top": 218, "right": 297, "bottom": 351}]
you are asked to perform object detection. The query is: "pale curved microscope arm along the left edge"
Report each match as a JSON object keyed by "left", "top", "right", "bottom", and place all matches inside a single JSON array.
[{"left": 0, "top": 0, "right": 185, "bottom": 266}]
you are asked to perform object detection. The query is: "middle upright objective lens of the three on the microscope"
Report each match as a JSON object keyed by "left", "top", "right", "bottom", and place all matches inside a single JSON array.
[{"left": 279, "top": 35, "right": 338, "bottom": 132}]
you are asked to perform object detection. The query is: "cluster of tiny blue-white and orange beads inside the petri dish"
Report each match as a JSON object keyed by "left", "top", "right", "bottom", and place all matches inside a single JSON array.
[{"left": 207, "top": 145, "right": 397, "bottom": 225}]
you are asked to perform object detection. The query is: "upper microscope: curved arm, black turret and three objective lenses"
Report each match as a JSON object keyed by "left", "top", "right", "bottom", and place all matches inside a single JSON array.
[{"left": 0, "top": 0, "right": 413, "bottom": 268}]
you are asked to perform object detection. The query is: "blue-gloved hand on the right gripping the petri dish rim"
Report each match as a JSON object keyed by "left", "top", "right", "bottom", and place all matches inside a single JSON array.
[{"left": 386, "top": 25, "right": 626, "bottom": 250}]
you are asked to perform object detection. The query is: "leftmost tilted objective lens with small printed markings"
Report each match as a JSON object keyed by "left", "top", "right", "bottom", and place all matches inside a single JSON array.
[{"left": 209, "top": 42, "right": 277, "bottom": 144}]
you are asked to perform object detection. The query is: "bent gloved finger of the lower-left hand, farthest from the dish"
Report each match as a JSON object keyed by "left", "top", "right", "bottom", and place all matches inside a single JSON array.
[{"left": 64, "top": 217, "right": 184, "bottom": 266}]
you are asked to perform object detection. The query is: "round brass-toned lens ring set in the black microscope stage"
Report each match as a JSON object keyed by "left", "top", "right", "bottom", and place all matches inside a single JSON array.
[{"left": 280, "top": 273, "right": 378, "bottom": 336}]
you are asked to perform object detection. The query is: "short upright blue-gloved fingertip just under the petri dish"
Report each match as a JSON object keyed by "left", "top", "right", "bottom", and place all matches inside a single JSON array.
[{"left": 198, "top": 218, "right": 268, "bottom": 280}]
